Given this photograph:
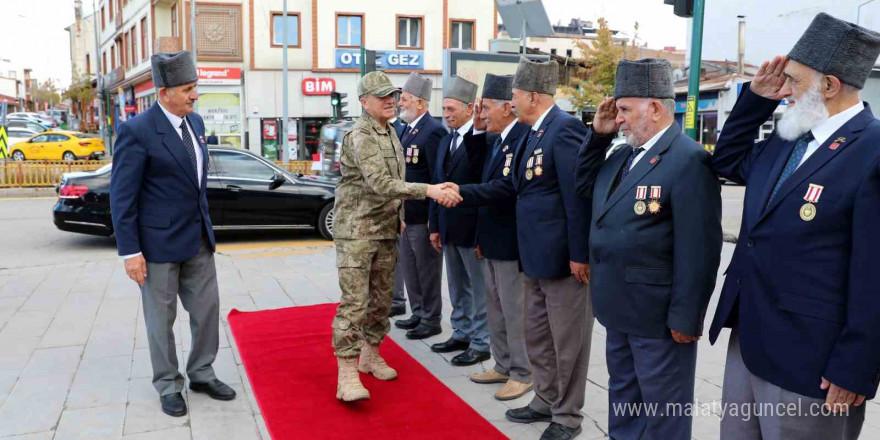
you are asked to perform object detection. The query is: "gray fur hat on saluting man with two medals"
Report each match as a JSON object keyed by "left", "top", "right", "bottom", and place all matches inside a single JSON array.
[{"left": 614, "top": 58, "right": 675, "bottom": 99}]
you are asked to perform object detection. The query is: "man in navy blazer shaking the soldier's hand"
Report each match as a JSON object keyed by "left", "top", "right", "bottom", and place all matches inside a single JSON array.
[{"left": 451, "top": 58, "right": 593, "bottom": 440}]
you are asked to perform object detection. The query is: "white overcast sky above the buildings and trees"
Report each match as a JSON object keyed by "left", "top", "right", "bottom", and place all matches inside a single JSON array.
[{"left": 0, "top": 0, "right": 687, "bottom": 87}]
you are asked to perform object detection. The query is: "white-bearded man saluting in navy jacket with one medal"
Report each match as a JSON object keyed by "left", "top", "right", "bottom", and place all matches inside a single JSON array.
[{"left": 709, "top": 13, "right": 880, "bottom": 440}]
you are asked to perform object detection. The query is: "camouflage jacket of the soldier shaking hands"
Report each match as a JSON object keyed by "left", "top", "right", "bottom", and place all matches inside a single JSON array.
[{"left": 333, "top": 112, "right": 428, "bottom": 240}]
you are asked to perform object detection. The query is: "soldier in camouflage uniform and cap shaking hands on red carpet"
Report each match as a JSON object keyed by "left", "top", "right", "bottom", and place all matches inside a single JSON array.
[{"left": 333, "top": 72, "right": 461, "bottom": 402}]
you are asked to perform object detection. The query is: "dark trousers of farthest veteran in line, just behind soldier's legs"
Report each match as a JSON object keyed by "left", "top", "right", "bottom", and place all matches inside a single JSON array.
[{"left": 394, "top": 224, "right": 443, "bottom": 328}]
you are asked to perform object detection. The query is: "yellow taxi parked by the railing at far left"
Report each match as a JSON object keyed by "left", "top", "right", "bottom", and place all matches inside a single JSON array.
[{"left": 9, "top": 131, "right": 107, "bottom": 161}]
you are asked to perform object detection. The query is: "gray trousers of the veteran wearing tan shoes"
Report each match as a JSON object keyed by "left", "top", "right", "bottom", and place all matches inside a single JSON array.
[{"left": 483, "top": 258, "right": 532, "bottom": 383}]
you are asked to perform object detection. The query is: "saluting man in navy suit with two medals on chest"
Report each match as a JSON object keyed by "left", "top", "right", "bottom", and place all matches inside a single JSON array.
[{"left": 576, "top": 58, "right": 722, "bottom": 440}]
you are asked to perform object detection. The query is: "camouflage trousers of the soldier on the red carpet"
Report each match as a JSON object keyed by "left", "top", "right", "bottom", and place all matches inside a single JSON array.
[{"left": 333, "top": 239, "right": 397, "bottom": 358}]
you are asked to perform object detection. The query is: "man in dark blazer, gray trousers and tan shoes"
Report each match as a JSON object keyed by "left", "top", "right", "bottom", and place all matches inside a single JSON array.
[{"left": 460, "top": 73, "right": 532, "bottom": 400}]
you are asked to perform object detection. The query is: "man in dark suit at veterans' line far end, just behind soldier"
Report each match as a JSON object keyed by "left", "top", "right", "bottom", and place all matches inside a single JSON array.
[{"left": 394, "top": 72, "right": 447, "bottom": 339}]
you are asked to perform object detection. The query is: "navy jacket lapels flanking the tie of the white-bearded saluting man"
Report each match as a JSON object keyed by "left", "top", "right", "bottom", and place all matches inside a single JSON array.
[{"left": 756, "top": 104, "right": 874, "bottom": 224}]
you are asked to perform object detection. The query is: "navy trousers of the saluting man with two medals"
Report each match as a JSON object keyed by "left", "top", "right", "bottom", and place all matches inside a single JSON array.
[{"left": 605, "top": 328, "right": 697, "bottom": 440}]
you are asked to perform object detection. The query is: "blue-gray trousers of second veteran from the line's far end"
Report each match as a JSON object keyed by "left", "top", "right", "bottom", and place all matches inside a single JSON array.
[{"left": 443, "top": 245, "right": 489, "bottom": 351}]
